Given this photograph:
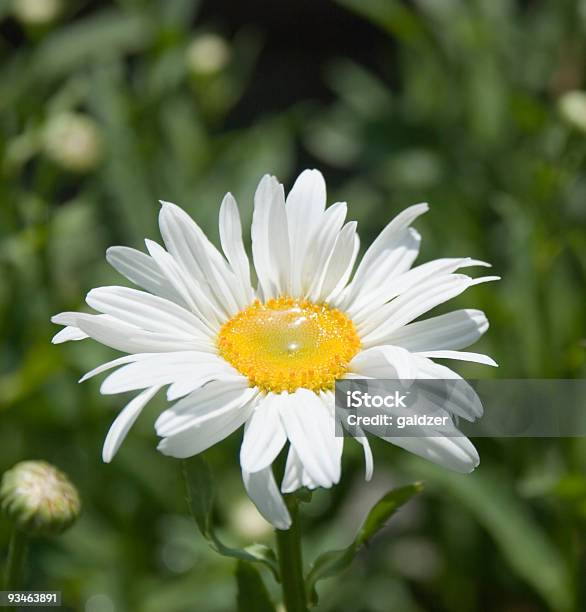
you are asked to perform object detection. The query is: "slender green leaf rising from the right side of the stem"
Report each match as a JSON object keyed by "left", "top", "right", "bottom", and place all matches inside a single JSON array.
[{"left": 306, "top": 482, "right": 423, "bottom": 605}]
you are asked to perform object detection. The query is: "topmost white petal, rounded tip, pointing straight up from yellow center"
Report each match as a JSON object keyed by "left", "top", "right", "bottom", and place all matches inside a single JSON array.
[{"left": 286, "top": 170, "right": 326, "bottom": 296}]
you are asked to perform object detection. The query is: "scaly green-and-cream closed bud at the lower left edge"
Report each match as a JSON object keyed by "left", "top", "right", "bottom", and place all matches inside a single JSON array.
[{"left": 0, "top": 461, "right": 81, "bottom": 535}]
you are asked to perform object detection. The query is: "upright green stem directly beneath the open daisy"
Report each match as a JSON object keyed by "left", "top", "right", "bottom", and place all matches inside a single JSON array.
[{"left": 276, "top": 495, "right": 307, "bottom": 612}]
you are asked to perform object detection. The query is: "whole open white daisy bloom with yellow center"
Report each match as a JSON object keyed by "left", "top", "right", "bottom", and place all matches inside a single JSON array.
[{"left": 52, "top": 170, "right": 496, "bottom": 529}]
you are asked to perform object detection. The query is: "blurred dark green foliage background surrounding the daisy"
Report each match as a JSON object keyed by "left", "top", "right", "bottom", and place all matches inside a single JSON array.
[{"left": 0, "top": 0, "right": 586, "bottom": 612}]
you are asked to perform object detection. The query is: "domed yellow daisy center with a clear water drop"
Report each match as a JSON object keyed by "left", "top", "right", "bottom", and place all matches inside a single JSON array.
[{"left": 218, "top": 297, "right": 360, "bottom": 393}]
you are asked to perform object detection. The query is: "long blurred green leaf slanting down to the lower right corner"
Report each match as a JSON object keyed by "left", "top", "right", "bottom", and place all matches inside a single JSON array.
[{"left": 406, "top": 458, "right": 572, "bottom": 612}]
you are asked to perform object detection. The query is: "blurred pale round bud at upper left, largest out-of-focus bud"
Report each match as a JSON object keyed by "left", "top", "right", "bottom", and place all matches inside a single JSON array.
[{"left": 44, "top": 113, "right": 102, "bottom": 172}]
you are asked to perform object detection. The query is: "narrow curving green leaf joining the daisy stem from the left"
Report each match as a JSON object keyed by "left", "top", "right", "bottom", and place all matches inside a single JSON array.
[{"left": 183, "top": 455, "right": 279, "bottom": 581}]
